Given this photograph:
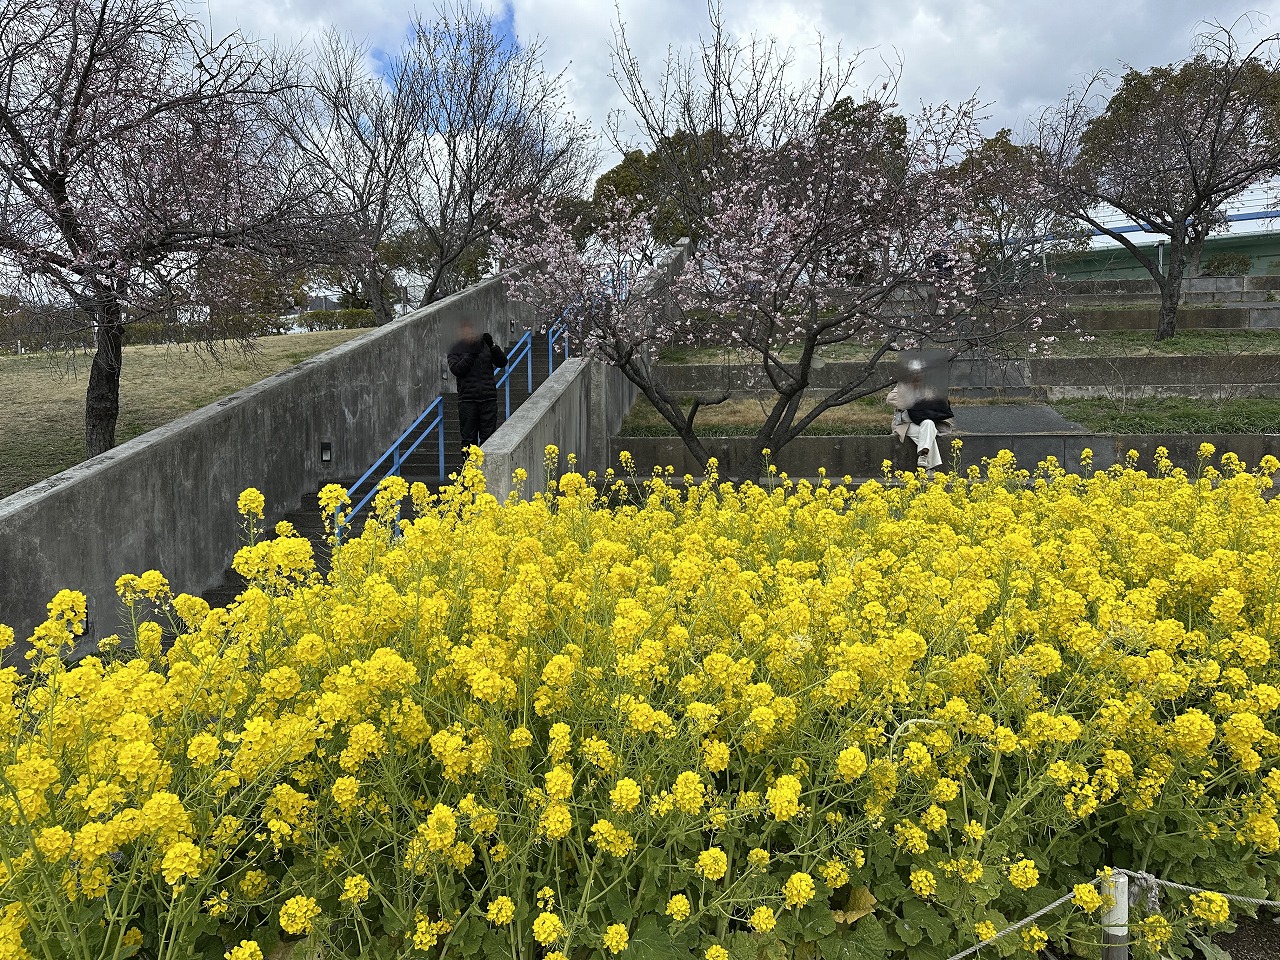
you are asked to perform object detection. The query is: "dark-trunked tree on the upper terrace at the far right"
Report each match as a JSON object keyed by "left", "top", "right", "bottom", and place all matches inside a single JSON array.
[{"left": 1036, "top": 22, "right": 1280, "bottom": 340}]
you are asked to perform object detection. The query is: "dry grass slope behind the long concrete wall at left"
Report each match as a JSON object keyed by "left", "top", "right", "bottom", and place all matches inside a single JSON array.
[{"left": 0, "top": 330, "right": 362, "bottom": 498}]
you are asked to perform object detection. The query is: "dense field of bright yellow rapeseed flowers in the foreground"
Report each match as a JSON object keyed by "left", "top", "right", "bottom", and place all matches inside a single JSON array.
[{"left": 0, "top": 449, "right": 1280, "bottom": 960}]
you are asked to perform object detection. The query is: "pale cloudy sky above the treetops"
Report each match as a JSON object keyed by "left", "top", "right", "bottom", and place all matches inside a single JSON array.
[{"left": 192, "top": 0, "right": 1280, "bottom": 166}]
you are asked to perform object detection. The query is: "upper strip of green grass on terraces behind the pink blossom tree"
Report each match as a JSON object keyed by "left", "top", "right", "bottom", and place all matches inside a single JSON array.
[{"left": 660, "top": 330, "right": 1280, "bottom": 364}]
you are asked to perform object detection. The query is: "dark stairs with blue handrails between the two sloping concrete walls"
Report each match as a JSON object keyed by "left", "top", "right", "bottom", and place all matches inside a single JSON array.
[{"left": 202, "top": 334, "right": 563, "bottom": 607}]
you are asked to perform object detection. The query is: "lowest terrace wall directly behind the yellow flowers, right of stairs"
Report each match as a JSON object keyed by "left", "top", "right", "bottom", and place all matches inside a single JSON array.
[{"left": 612, "top": 434, "right": 1280, "bottom": 480}]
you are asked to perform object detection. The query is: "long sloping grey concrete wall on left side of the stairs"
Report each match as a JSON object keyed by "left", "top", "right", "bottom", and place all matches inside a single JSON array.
[{"left": 0, "top": 279, "right": 530, "bottom": 641}]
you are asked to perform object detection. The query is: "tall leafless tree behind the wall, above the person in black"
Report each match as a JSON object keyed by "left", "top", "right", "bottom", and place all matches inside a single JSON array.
[{"left": 394, "top": 1, "right": 596, "bottom": 303}]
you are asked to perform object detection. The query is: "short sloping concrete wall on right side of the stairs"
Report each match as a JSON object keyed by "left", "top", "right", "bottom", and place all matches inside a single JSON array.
[{"left": 484, "top": 360, "right": 637, "bottom": 499}]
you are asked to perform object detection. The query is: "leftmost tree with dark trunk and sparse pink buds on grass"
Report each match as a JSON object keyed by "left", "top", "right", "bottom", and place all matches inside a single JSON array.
[{"left": 0, "top": 0, "right": 335, "bottom": 456}]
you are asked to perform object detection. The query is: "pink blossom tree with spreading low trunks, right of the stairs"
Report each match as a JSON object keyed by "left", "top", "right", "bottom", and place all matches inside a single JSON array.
[{"left": 503, "top": 101, "right": 1052, "bottom": 471}]
